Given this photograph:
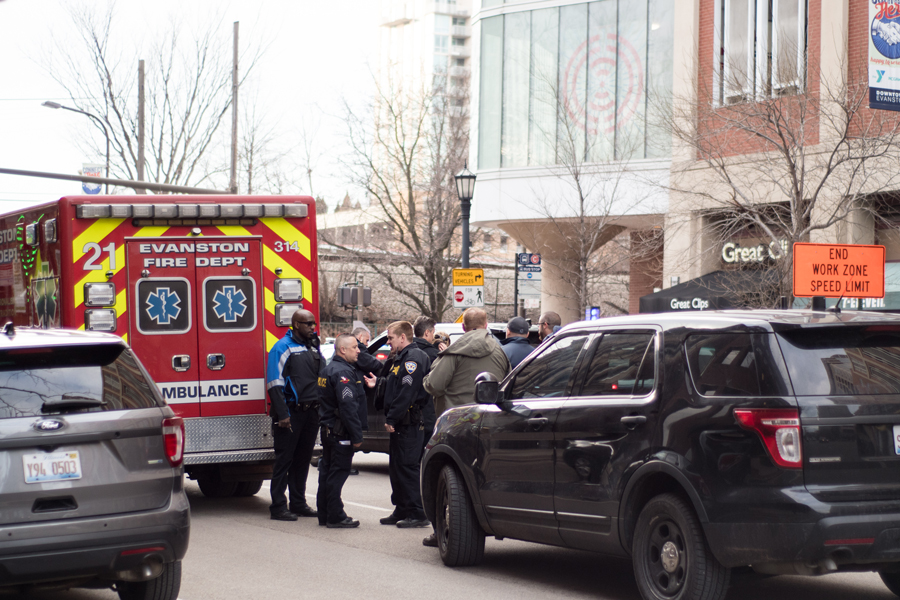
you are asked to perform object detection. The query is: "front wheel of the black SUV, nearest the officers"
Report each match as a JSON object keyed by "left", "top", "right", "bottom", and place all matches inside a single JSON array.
[{"left": 435, "top": 465, "right": 484, "bottom": 567}]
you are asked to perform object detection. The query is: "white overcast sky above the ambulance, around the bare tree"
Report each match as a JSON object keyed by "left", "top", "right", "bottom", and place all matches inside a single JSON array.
[{"left": 0, "top": 0, "right": 378, "bottom": 212}]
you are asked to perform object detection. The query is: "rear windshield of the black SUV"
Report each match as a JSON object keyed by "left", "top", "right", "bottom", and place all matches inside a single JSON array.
[{"left": 778, "top": 325, "right": 900, "bottom": 396}]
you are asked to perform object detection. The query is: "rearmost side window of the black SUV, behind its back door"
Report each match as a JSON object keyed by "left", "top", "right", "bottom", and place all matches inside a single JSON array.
[{"left": 684, "top": 332, "right": 788, "bottom": 397}]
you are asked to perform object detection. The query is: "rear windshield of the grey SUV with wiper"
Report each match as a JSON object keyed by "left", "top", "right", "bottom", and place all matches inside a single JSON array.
[{"left": 0, "top": 345, "right": 159, "bottom": 419}]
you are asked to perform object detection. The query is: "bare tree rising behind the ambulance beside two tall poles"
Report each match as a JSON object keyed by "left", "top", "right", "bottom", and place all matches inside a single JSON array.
[{"left": 44, "top": 4, "right": 261, "bottom": 190}]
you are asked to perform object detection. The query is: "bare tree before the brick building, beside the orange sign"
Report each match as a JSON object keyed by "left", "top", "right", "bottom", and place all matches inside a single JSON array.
[{"left": 666, "top": 42, "right": 900, "bottom": 306}]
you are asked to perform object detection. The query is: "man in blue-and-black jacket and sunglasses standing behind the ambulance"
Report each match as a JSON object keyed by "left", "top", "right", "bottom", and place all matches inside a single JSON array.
[{"left": 266, "top": 309, "right": 325, "bottom": 521}]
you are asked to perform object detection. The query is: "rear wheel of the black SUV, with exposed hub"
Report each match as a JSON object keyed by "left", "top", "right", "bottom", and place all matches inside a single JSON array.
[{"left": 632, "top": 494, "right": 730, "bottom": 600}]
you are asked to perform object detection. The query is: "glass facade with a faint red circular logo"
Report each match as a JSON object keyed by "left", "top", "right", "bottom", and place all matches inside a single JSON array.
[{"left": 477, "top": 0, "right": 674, "bottom": 170}]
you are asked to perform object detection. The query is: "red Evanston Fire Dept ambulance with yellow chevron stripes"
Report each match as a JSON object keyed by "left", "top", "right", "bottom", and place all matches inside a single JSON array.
[{"left": 0, "top": 195, "right": 319, "bottom": 496}]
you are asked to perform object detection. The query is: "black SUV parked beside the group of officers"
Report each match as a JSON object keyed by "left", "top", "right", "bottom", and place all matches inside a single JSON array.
[{"left": 422, "top": 311, "right": 900, "bottom": 600}]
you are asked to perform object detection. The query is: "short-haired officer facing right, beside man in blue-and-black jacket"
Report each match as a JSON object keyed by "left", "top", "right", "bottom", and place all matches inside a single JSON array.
[{"left": 316, "top": 333, "right": 380, "bottom": 528}]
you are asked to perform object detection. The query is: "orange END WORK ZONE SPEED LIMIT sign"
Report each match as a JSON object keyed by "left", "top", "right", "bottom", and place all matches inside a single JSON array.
[{"left": 794, "top": 243, "right": 885, "bottom": 298}]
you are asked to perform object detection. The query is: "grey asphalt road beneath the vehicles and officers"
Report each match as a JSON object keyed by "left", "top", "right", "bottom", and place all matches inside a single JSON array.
[{"left": 22, "top": 454, "right": 896, "bottom": 600}]
